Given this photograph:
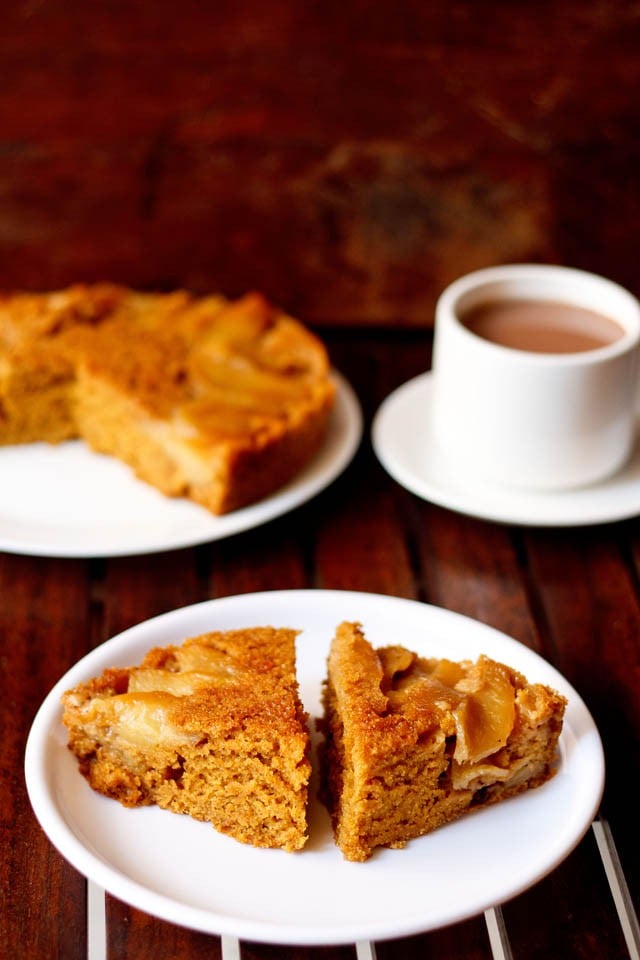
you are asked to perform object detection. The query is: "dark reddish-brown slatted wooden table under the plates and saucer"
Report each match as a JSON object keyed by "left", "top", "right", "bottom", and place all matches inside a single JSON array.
[{"left": 0, "top": 331, "right": 640, "bottom": 960}]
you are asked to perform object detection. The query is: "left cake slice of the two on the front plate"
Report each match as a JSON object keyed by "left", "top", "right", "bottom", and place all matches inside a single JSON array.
[{"left": 62, "top": 627, "right": 311, "bottom": 851}]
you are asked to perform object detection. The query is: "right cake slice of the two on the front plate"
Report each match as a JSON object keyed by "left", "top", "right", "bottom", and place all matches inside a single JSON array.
[{"left": 320, "top": 623, "right": 566, "bottom": 861}]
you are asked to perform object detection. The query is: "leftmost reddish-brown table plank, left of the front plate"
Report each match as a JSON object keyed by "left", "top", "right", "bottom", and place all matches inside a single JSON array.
[{"left": 0, "top": 553, "right": 90, "bottom": 960}]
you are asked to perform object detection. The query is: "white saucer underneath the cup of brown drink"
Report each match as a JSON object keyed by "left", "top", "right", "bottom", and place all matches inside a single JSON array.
[{"left": 372, "top": 373, "right": 640, "bottom": 527}]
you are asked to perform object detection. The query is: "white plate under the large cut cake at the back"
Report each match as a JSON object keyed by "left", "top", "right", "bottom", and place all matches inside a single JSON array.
[{"left": 0, "top": 373, "right": 362, "bottom": 557}]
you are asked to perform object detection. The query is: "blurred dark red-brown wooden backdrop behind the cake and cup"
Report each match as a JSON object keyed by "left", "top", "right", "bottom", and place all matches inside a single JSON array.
[{"left": 0, "top": 0, "right": 640, "bottom": 327}]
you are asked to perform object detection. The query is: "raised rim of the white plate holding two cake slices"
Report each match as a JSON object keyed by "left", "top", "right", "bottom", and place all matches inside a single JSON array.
[{"left": 24, "top": 589, "right": 605, "bottom": 946}]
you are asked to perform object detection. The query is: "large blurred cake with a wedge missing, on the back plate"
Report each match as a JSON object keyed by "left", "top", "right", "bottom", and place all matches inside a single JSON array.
[{"left": 0, "top": 284, "right": 335, "bottom": 514}]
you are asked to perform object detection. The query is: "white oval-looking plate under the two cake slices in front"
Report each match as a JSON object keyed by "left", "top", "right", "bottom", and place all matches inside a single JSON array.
[{"left": 25, "top": 590, "right": 604, "bottom": 945}]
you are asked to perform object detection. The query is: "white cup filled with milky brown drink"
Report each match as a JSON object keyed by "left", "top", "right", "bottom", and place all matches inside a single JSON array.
[{"left": 432, "top": 264, "right": 640, "bottom": 490}]
